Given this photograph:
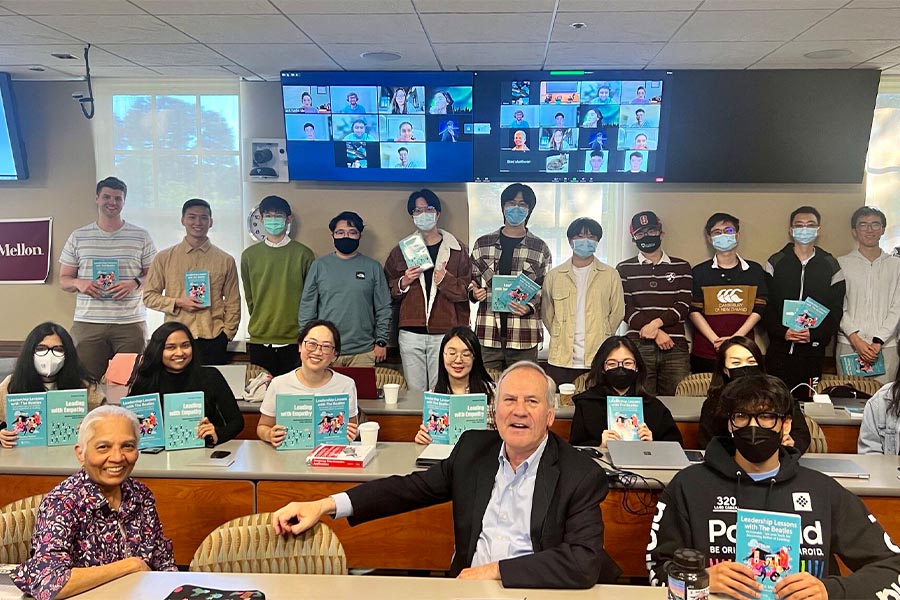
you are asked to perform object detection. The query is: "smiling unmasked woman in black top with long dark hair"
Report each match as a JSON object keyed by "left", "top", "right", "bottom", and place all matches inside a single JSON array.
[{"left": 129, "top": 321, "right": 244, "bottom": 446}]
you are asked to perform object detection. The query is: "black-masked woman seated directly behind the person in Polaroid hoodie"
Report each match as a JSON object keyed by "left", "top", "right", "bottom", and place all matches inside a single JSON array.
[{"left": 697, "top": 336, "right": 810, "bottom": 454}]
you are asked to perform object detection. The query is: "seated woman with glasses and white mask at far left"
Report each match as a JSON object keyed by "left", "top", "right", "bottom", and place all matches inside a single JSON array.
[{"left": 0, "top": 322, "right": 106, "bottom": 448}]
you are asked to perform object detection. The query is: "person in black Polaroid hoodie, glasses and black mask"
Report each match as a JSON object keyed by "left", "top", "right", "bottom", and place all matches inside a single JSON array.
[{"left": 647, "top": 375, "right": 900, "bottom": 600}]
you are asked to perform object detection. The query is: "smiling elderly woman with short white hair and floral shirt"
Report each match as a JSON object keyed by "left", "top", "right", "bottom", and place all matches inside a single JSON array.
[{"left": 13, "top": 405, "right": 178, "bottom": 600}]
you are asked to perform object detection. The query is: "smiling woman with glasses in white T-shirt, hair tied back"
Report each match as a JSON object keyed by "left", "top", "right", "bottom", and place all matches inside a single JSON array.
[{"left": 256, "top": 319, "right": 359, "bottom": 448}]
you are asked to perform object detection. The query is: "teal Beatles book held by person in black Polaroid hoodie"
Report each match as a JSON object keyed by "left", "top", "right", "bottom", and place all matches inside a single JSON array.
[{"left": 735, "top": 509, "right": 800, "bottom": 600}]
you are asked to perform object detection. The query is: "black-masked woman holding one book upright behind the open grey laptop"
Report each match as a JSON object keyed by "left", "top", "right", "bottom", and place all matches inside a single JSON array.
[{"left": 569, "top": 336, "right": 682, "bottom": 447}]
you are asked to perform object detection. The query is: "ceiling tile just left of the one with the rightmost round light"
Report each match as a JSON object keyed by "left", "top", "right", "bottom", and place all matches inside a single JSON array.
[{"left": 650, "top": 42, "right": 779, "bottom": 69}]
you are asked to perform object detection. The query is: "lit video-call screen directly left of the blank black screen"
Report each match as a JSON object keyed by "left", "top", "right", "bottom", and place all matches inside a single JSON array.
[{"left": 473, "top": 71, "right": 675, "bottom": 182}]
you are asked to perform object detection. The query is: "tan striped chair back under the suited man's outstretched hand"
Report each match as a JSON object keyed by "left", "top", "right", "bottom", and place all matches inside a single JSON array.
[{"left": 190, "top": 513, "right": 347, "bottom": 575}]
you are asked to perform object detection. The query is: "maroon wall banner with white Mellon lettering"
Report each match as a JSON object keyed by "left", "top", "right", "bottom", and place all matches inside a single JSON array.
[{"left": 0, "top": 217, "right": 53, "bottom": 283}]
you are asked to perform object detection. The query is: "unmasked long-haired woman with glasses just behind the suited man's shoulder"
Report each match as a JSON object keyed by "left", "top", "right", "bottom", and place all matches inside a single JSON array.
[{"left": 415, "top": 327, "right": 497, "bottom": 444}]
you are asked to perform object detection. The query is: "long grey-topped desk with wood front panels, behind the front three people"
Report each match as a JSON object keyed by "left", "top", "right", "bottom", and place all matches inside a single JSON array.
[{"left": 0, "top": 440, "right": 900, "bottom": 577}]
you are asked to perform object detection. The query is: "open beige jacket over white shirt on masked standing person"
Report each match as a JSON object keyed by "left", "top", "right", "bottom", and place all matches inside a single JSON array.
[{"left": 541, "top": 258, "right": 625, "bottom": 367}]
